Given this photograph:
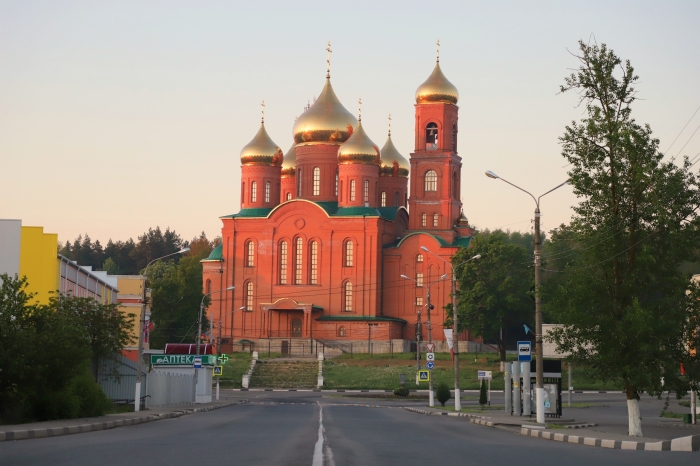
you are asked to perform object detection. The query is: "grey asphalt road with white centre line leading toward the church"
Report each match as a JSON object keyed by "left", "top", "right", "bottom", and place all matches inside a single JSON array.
[{"left": 0, "top": 392, "right": 700, "bottom": 466}]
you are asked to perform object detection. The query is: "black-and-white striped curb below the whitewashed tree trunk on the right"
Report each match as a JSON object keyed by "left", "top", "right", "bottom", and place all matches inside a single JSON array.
[{"left": 520, "top": 427, "right": 700, "bottom": 451}]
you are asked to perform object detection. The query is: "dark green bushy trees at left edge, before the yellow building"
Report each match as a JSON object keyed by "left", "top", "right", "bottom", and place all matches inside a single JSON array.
[{"left": 0, "top": 274, "right": 134, "bottom": 422}]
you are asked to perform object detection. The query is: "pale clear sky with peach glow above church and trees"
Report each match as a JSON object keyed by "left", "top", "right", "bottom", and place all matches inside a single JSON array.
[{"left": 0, "top": 0, "right": 700, "bottom": 244}]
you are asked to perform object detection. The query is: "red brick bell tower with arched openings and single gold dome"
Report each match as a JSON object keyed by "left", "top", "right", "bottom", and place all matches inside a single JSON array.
[{"left": 408, "top": 49, "right": 462, "bottom": 242}]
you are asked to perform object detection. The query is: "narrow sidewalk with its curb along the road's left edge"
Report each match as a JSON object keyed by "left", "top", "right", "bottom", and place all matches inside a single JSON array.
[{"left": 0, "top": 397, "right": 245, "bottom": 442}]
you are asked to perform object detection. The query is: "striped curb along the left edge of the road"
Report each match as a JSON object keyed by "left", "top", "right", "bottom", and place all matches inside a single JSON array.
[{"left": 0, "top": 401, "right": 239, "bottom": 442}]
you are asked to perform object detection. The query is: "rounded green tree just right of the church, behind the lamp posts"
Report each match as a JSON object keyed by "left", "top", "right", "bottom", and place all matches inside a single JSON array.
[{"left": 443, "top": 230, "right": 534, "bottom": 361}]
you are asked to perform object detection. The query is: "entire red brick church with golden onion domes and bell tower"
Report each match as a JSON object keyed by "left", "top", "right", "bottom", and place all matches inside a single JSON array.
[{"left": 202, "top": 48, "right": 474, "bottom": 350}]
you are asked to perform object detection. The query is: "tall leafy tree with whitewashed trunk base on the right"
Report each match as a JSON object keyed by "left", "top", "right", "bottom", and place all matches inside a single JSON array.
[{"left": 542, "top": 42, "right": 700, "bottom": 436}]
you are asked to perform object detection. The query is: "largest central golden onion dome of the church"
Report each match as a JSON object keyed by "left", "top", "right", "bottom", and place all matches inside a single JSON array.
[{"left": 292, "top": 78, "right": 357, "bottom": 144}]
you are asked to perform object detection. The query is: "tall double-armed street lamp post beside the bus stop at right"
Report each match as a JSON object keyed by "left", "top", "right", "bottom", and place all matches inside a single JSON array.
[{"left": 486, "top": 170, "right": 571, "bottom": 424}]
